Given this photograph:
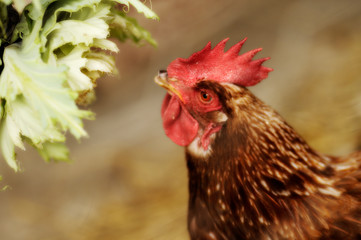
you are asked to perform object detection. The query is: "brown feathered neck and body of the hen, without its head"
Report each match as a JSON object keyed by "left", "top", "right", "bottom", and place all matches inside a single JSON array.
[{"left": 186, "top": 82, "right": 361, "bottom": 240}]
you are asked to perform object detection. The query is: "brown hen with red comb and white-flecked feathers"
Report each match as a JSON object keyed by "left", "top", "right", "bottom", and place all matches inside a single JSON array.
[{"left": 155, "top": 39, "right": 361, "bottom": 240}]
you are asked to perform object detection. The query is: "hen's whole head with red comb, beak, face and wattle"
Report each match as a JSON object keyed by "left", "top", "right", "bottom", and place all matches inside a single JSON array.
[{"left": 155, "top": 38, "right": 272, "bottom": 150}]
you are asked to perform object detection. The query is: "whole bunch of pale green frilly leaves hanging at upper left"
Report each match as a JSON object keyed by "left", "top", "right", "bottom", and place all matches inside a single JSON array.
[{"left": 0, "top": 0, "right": 158, "bottom": 171}]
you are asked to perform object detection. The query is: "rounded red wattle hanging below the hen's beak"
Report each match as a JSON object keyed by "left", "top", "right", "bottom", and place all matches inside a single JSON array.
[{"left": 161, "top": 93, "right": 199, "bottom": 146}]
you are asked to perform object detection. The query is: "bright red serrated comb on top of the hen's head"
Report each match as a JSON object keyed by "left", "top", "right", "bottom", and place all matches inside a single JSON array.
[{"left": 167, "top": 38, "right": 273, "bottom": 87}]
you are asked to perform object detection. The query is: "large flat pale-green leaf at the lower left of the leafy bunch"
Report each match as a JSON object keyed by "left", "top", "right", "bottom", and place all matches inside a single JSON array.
[{"left": 0, "top": 44, "right": 93, "bottom": 170}]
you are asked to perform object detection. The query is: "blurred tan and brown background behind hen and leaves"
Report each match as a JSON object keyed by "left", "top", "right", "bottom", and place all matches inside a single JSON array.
[{"left": 0, "top": 0, "right": 361, "bottom": 240}]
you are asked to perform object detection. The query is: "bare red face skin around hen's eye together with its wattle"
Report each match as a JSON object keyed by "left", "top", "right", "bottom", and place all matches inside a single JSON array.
[{"left": 161, "top": 82, "right": 222, "bottom": 149}]
